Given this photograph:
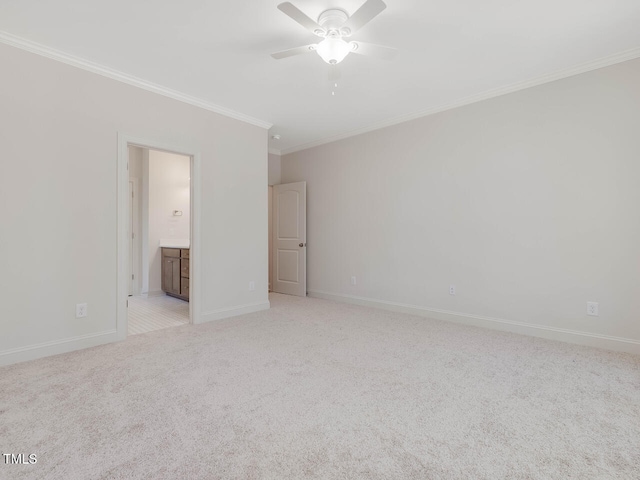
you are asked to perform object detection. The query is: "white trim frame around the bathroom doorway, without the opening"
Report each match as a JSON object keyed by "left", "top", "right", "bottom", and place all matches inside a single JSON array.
[{"left": 116, "top": 132, "right": 202, "bottom": 340}]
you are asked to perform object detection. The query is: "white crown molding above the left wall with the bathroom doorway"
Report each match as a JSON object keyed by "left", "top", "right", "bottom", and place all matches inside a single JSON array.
[{"left": 0, "top": 31, "right": 273, "bottom": 130}]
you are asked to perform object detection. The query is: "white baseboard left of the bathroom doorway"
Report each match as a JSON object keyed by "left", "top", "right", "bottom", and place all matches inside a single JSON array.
[{"left": 0, "top": 330, "right": 118, "bottom": 365}]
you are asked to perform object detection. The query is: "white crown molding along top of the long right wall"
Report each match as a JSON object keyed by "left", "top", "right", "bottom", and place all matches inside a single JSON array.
[{"left": 281, "top": 47, "right": 640, "bottom": 155}]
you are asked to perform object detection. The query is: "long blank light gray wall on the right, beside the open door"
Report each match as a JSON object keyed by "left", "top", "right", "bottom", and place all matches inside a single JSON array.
[{"left": 282, "top": 60, "right": 640, "bottom": 351}]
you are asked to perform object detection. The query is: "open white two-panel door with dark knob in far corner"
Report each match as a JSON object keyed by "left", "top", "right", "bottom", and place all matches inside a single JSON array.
[{"left": 273, "top": 182, "right": 307, "bottom": 297}]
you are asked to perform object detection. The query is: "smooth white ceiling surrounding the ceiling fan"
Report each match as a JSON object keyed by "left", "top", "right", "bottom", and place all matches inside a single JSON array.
[{"left": 0, "top": 0, "right": 640, "bottom": 152}]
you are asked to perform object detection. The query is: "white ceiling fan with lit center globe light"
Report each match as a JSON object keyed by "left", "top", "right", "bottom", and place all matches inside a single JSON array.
[{"left": 271, "top": 0, "right": 397, "bottom": 65}]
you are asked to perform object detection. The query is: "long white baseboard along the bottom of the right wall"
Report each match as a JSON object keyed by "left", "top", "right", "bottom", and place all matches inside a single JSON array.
[{"left": 308, "top": 290, "right": 640, "bottom": 355}]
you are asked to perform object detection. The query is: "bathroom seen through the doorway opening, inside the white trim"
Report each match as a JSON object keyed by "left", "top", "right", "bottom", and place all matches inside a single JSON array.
[{"left": 127, "top": 145, "right": 191, "bottom": 335}]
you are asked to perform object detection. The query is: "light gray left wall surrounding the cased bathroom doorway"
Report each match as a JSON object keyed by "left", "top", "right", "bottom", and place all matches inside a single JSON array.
[{"left": 0, "top": 45, "right": 268, "bottom": 363}]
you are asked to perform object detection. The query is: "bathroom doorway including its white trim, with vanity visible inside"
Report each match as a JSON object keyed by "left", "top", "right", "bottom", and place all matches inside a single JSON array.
[{"left": 117, "top": 135, "right": 200, "bottom": 339}]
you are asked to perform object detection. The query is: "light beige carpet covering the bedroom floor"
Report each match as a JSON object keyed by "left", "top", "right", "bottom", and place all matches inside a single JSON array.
[{"left": 0, "top": 295, "right": 640, "bottom": 480}]
